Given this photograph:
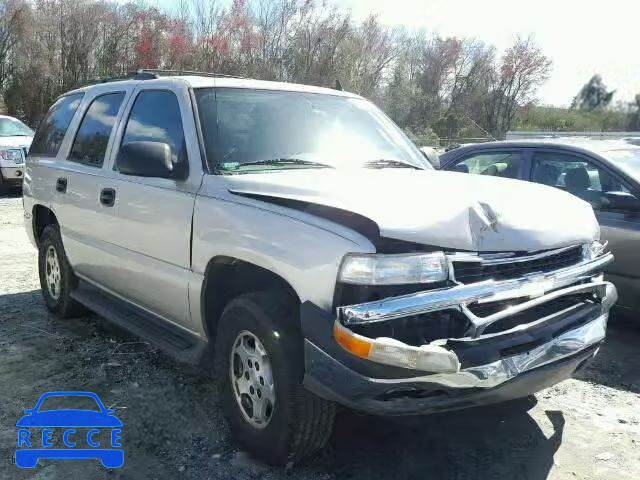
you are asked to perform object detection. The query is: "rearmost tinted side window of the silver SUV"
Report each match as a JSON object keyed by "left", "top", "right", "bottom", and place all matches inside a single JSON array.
[{"left": 29, "top": 93, "right": 84, "bottom": 157}]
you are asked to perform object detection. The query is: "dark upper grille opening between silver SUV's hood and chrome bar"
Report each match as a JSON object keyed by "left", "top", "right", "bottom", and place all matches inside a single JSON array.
[{"left": 452, "top": 246, "right": 582, "bottom": 284}]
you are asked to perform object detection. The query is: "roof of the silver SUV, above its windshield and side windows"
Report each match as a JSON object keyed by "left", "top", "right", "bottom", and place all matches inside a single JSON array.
[{"left": 67, "top": 75, "right": 362, "bottom": 98}]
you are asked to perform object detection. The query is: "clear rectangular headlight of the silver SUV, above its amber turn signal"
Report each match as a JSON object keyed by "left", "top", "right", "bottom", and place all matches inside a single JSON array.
[{"left": 339, "top": 252, "right": 449, "bottom": 285}]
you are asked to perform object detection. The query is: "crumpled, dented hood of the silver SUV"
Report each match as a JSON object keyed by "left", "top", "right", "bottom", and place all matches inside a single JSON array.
[{"left": 224, "top": 169, "right": 600, "bottom": 252}]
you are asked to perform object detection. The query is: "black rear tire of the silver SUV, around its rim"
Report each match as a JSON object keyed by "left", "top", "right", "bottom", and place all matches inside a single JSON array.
[{"left": 38, "top": 225, "right": 85, "bottom": 318}]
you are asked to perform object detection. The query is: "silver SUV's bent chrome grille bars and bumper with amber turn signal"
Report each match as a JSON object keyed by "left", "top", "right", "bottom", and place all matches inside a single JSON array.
[{"left": 334, "top": 253, "right": 617, "bottom": 376}]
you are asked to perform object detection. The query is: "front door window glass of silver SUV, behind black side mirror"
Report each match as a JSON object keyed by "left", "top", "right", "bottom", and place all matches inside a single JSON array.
[{"left": 122, "top": 90, "right": 187, "bottom": 167}]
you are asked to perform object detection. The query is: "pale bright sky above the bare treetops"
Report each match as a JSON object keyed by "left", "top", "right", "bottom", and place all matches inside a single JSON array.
[{"left": 147, "top": 0, "right": 640, "bottom": 106}]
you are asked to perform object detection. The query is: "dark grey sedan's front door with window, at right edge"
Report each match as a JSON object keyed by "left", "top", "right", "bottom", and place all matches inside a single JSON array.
[{"left": 530, "top": 149, "right": 640, "bottom": 308}]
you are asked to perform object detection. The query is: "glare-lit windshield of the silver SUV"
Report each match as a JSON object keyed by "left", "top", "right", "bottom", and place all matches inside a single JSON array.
[{"left": 196, "top": 88, "right": 425, "bottom": 173}]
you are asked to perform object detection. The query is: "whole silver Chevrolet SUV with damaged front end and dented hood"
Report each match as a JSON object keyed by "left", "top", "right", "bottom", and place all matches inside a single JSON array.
[{"left": 24, "top": 70, "right": 616, "bottom": 463}]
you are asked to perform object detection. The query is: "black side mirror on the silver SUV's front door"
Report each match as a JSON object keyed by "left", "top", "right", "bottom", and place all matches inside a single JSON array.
[{"left": 116, "top": 141, "right": 188, "bottom": 180}]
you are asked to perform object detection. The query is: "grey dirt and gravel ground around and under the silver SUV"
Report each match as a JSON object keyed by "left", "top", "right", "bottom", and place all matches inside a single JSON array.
[{"left": 0, "top": 192, "right": 640, "bottom": 480}]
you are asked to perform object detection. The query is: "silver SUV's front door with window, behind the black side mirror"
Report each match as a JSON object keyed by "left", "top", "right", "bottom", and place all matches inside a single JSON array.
[{"left": 95, "top": 80, "right": 203, "bottom": 330}]
